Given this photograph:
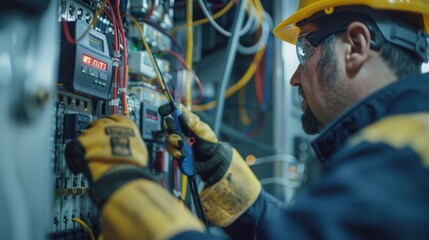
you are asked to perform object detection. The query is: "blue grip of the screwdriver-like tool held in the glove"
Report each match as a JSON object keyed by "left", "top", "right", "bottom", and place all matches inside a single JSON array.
[{"left": 171, "top": 108, "right": 197, "bottom": 177}]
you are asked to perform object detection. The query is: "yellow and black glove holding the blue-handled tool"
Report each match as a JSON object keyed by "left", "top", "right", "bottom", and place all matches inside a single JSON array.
[{"left": 159, "top": 104, "right": 261, "bottom": 227}]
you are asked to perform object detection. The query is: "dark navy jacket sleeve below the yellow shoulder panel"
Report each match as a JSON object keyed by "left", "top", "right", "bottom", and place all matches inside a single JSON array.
[{"left": 225, "top": 142, "right": 429, "bottom": 240}]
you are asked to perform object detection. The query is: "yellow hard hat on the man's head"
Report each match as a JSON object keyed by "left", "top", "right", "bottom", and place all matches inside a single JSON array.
[{"left": 273, "top": 0, "right": 429, "bottom": 44}]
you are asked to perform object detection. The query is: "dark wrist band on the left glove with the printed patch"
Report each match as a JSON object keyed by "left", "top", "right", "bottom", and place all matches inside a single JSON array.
[{"left": 90, "top": 165, "right": 155, "bottom": 208}]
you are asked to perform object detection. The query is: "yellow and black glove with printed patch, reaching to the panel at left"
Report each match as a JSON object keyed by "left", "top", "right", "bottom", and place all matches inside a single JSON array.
[{"left": 65, "top": 115, "right": 204, "bottom": 240}]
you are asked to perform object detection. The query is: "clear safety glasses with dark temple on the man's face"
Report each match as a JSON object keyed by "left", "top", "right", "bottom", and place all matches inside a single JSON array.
[{"left": 296, "top": 26, "right": 347, "bottom": 64}]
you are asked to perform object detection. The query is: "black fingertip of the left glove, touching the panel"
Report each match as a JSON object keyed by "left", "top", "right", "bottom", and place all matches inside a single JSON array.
[{"left": 64, "top": 140, "right": 86, "bottom": 174}]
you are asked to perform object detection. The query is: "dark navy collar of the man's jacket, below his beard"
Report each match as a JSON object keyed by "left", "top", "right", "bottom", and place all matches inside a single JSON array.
[{"left": 312, "top": 73, "right": 429, "bottom": 164}]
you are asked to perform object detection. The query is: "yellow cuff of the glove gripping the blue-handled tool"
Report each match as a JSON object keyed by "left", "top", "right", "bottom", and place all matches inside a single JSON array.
[{"left": 201, "top": 149, "right": 261, "bottom": 227}]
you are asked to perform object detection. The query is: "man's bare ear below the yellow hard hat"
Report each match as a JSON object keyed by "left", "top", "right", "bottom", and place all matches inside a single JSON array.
[{"left": 344, "top": 22, "right": 371, "bottom": 76}]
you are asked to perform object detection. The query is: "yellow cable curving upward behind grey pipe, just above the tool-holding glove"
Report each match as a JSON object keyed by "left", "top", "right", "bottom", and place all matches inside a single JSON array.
[{"left": 192, "top": 46, "right": 265, "bottom": 112}]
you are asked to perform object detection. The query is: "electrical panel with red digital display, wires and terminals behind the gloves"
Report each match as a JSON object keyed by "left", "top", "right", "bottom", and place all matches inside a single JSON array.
[{"left": 49, "top": 0, "right": 176, "bottom": 239}]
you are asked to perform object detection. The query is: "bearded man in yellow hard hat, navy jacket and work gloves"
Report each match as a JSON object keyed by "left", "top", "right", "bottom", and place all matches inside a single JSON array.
[{"left": 66, "top": 0, "right": 429, "bottom": 239}]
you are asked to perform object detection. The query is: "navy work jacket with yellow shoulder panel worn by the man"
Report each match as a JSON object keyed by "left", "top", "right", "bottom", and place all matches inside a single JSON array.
[{"left": 171, "top": 73, "right": 429, "bottom": 240}]
